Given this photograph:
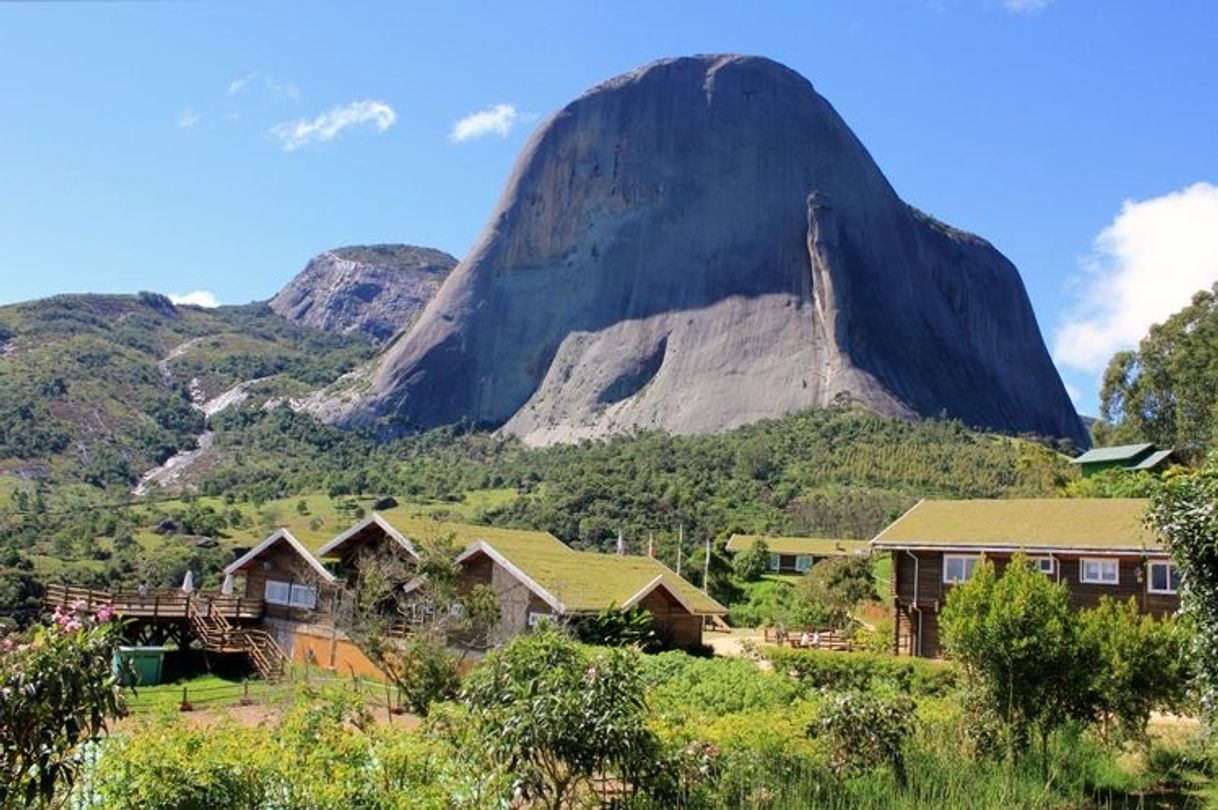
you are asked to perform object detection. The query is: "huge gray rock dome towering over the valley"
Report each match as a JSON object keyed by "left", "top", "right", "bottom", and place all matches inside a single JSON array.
[{"left": 330, "top": 56, "right": 1088, "bottom": 446}]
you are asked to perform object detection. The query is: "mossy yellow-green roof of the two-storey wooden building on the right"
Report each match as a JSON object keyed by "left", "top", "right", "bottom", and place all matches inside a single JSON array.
[{"left": 872, "top": 498, "right": 1162, "bottom": 551}]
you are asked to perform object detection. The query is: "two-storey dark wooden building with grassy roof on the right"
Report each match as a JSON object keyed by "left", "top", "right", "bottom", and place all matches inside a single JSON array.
[{"left": 871, "top": 498, "right": 1180, "bottom": 658}]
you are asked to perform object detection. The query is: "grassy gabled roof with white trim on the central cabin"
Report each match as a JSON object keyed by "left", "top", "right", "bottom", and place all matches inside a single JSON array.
[{"left": 457, "top": 535, "right": 727, "bottom": 615}]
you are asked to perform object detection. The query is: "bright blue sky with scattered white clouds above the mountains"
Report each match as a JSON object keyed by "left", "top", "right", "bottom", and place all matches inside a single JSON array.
[{"left": 0, "top": 0, "right": 1218, "bottom": 413}]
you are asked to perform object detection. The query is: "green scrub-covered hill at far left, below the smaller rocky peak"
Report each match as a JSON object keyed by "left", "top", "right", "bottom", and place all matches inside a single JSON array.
[{"left": 0, "top": 292, "right": 373, "bottom": 490}]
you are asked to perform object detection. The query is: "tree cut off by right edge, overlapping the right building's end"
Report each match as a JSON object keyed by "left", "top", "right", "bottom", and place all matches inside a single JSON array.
[{"left": 1147, "top": 454, "right": 1218, "bottom": 725}]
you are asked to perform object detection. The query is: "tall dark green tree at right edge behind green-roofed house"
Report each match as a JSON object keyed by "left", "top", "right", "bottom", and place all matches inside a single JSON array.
[{"left": 1100, "top": 284, "right": 1218, "bottom": 458}]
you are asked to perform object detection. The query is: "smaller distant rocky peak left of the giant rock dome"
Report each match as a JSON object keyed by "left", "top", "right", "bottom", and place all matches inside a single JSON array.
[{"left": 270, "top": 239, "right": 457, "bottom": 343}]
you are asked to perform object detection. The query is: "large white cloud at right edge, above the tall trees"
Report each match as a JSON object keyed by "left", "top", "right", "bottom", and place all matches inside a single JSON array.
[{"left": 1054, "top": 183, "right": 1218, "bottom": 373}]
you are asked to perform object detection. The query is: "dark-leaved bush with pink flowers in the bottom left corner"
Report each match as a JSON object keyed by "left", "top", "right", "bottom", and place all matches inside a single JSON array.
[{"left": 0, "top": 596, "right": 123, "bottom": 810}]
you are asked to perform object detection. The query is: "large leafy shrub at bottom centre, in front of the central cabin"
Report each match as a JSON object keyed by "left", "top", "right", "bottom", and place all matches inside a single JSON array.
[{"left": 462, "top": 626, "right": 661, "bottom": 810}]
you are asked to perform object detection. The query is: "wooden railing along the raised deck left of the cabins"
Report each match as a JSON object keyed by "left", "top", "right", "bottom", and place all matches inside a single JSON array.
[{"left": 44, "top": 585, "right": 263, "bottom": 621}]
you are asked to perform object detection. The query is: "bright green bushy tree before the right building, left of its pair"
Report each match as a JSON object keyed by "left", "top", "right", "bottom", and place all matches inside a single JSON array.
[{"left": 940, "top": 554, "right": 1093, "bottom": 764}]
